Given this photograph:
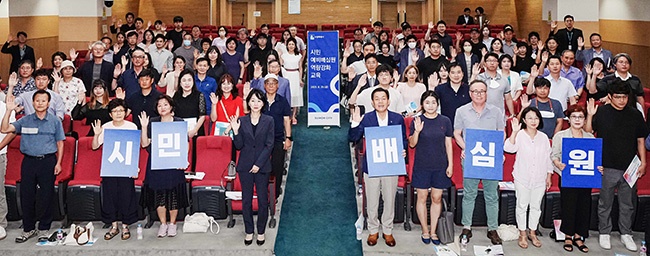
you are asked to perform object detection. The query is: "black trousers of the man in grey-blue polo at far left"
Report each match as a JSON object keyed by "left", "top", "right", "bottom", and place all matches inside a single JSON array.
[{"left": 20, "top": 154, "right": 56, "bottom": 232}]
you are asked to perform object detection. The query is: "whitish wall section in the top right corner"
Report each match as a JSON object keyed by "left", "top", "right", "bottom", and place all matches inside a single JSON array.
[{"left": 599, "top": 0, "right": 650, "bottom": 21}]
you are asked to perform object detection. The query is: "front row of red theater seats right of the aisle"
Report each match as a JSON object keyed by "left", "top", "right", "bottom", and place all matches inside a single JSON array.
[{"left": 355, "top": 117, "right": 650, "bottom": 231}]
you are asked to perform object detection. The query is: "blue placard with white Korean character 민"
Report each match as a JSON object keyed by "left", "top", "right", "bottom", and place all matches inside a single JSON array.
[{"left": 150, "top": 122, "right": 188, "bottom": 170}]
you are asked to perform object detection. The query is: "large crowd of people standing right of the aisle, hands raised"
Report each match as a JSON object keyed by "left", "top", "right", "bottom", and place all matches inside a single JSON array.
[{"left": 341, "top": 7, "right": 649, "bottom": 252}]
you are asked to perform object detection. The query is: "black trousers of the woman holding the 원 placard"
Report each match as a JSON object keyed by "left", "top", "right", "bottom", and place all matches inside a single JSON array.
[{"left": 560, "top": 187, "right": 591, "bottom": 237}]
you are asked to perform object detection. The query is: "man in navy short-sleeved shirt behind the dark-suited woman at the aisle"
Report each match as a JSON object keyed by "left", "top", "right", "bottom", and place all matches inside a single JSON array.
[{"left": 264, "top": 74, "right": 293, "bottom": 199}]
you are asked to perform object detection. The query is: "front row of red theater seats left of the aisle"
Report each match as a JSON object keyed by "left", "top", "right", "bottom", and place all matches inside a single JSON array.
[{"left": 5, "top": 136, "right": 276, "bottom": 228}]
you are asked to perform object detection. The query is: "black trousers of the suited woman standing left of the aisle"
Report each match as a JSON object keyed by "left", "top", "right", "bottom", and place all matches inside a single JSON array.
[{"left": 239, "top": 171, "right": 269, "bottom": 235}]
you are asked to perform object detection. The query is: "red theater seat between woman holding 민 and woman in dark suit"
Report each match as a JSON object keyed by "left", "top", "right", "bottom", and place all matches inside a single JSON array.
[{"left": 191, "top": 136, "right": 232, "bottom": 219}]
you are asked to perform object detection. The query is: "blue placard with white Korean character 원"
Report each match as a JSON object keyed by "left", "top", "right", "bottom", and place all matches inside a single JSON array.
[{"left": 562, "top": 138, "right": 603, "bottom": 188}]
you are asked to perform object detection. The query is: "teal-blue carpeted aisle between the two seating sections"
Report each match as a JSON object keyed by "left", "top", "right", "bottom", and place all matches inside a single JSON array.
[{"left": 275, "top": 111, "right": 362, "bottom": 256}]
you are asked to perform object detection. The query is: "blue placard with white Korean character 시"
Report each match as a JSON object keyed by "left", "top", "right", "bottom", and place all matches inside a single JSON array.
[{"left": 100, "top": 129, "right": 140, "bottom": 177}]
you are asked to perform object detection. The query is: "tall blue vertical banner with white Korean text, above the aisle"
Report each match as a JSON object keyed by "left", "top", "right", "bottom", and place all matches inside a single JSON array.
[{"left": 307, "top": 31, "right": 340, "bottom": 126}]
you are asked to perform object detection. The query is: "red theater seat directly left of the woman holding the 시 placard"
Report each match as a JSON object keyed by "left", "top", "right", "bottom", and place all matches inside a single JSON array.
[{"left": 66, "top": 137, "right": 102, "bottom": 221}]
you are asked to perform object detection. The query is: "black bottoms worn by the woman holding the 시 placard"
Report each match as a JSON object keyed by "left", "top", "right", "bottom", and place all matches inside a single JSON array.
[{"left": 102, "top": 177, "right": 138, "bottom": 225}]
